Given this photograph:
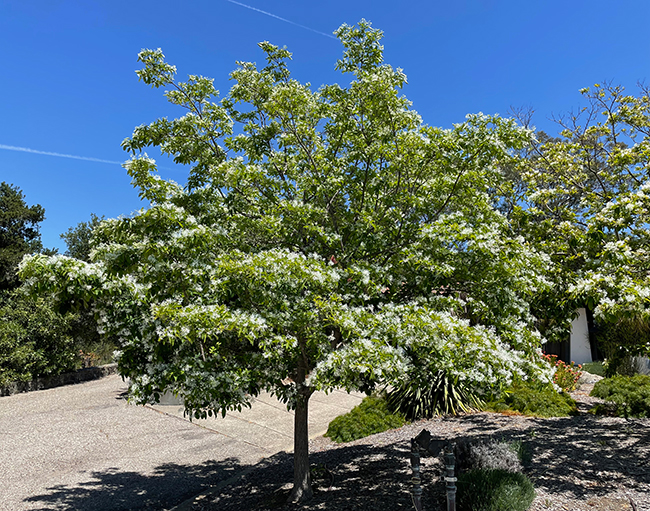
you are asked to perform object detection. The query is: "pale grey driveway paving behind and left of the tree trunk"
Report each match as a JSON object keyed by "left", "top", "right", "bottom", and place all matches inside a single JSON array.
[{"left": 0, "top": 375, "right": 362, "bottom": 511}]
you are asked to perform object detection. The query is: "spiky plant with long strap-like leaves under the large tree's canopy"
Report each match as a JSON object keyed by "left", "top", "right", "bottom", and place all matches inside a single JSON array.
[{"left": 386, "top": 371, "right": 484, "bottom": 420}]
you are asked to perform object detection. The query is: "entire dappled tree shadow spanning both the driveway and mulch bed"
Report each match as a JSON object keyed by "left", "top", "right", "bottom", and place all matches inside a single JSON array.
[{"left": 20, "top": 414, "right": 650, "bottom": 511}]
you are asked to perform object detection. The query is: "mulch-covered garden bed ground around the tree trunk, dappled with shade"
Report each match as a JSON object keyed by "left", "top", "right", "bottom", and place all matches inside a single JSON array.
[{"left": 189, "top": 383, "right": 650, "bottom": 511}]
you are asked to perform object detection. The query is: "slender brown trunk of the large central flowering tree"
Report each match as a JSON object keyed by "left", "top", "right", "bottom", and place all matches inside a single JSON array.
[{"left": 289, "top": 350, "right": 314, "bottom": 502}]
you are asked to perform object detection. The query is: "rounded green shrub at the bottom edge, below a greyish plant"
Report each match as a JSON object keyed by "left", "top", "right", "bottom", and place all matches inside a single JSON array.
[{"left": 457, "top": 469, "right": 535, "bottom": 511}]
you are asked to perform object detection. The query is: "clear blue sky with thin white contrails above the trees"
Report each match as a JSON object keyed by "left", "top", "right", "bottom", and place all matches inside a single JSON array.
[{"left": 0, "top": 0, "right": 650, "bottom": 251}]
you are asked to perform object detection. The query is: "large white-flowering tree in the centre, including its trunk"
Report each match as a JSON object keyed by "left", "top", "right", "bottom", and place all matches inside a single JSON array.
[{"left": 22, "top": 21, "right": 549, "bottom": 499}]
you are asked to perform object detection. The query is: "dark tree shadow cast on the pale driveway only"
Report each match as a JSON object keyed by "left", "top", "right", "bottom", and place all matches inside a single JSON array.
[{"left": 25, "top": 458, "right": 246, "bottom": 511}]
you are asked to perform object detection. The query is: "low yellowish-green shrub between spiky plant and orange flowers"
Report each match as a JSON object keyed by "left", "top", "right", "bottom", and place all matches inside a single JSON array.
[{"left": 486, "top": 381, "right": 578, "bottom": 417}]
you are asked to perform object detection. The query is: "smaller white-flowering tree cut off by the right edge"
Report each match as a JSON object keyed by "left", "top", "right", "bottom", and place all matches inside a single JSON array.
[{"left": 507, "top": 84, "right": 650, "bottom": 354}]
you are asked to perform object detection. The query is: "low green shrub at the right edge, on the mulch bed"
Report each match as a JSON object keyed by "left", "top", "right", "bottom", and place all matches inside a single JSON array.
[{"left": 590, "top": 375, "right": 650, "bottom": 418}]
